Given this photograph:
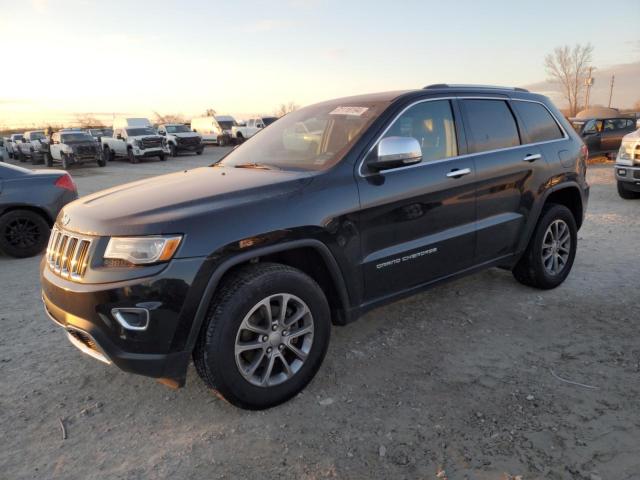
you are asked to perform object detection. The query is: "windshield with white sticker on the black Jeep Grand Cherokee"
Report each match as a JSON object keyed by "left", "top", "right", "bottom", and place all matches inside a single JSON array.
[{"left": 219, "top": 100, "right": 388, "bottom": 170}]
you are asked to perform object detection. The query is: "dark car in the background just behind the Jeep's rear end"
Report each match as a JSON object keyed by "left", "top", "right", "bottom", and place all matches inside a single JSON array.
[{"left": 571, "top": 117, "right": 637, "bottom": 155}]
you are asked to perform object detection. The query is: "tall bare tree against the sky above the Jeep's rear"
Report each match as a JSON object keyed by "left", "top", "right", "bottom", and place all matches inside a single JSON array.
[{"left": 544, "top": 43, "right": 593, "bottom": 116}]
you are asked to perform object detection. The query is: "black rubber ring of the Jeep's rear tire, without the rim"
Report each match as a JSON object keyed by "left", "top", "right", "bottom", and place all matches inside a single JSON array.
[{"left": 532, "top": 205, "right": 578, "bottom": 288}]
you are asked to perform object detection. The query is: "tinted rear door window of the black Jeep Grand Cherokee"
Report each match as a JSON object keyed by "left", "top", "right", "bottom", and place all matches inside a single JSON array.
[{"left": 462, "top": 99, "right": 520, "bottom": 153}]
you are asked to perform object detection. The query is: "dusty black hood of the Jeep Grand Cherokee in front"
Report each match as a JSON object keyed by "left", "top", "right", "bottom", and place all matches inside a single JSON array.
[{"left": 58, "top": 167, "right": 310, "bottom": 236}]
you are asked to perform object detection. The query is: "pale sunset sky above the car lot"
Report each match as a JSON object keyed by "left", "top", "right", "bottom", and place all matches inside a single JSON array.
[{"left": 0, "top": 0, "right": 640, "bottom": 127}]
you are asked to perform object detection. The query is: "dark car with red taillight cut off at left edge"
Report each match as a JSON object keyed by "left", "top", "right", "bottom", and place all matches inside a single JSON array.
[{"left": 0, "top": 163, "right": 78, "bottom": 258}]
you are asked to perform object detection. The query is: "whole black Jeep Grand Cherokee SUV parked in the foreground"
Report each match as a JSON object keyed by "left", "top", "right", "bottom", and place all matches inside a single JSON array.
[{"left": 41, "top": 85, "right": 589, "bottom": 409}]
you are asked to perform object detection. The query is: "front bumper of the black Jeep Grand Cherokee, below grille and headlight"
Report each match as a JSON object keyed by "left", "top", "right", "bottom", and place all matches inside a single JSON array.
[{"left": 40, "top": 258, "right": 202, "bottom": 384}]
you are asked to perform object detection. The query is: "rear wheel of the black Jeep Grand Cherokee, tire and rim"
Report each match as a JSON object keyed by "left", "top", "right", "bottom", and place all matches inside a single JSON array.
[{"left": 512, "top": 204, "right": 578, "bottom": 290}]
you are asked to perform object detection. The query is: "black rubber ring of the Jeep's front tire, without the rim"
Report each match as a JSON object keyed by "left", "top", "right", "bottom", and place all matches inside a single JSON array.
[{"left": 205, "top": 270, "right": 331, "bottom": 408}]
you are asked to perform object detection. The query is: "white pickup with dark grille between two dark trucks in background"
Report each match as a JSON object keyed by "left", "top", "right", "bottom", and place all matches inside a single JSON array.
[{"left": 100, "top": 118, "right": 169, "bottom": 163}]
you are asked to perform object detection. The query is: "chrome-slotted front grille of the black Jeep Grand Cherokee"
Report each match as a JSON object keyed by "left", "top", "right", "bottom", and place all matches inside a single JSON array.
[{"left": 47, "top": 227, "right": 91, "bottom": 280}]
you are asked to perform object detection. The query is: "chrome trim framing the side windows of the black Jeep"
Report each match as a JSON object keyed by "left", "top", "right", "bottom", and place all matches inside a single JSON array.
[{"left": 356, "top": 94, "right": 570, "bottom": 178}]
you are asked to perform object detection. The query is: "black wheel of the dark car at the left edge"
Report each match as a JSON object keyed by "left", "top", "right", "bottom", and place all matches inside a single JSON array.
[{"left": 0, "top": 210, "right": 51, "bottom": 258}]
